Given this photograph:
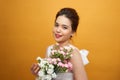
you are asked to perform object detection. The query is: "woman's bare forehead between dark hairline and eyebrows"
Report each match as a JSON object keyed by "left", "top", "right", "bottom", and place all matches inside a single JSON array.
[{"left": 56, "top": 15, "right": 71, "bottom": 26}]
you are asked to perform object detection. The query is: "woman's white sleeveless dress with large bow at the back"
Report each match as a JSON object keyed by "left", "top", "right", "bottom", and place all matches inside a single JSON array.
[{"left": 47, "top": 45, "right": 89, "bottom": 80}]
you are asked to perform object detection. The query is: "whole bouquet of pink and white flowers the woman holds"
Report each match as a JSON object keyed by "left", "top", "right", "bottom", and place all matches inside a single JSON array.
[{"left": 37, "top": 45, "right": 73, "bottom": 80}]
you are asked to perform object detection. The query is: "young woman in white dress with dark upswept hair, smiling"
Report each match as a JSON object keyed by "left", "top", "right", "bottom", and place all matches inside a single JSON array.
[{"left": 31, "top": 8, "right": 88, "bottom": 80}]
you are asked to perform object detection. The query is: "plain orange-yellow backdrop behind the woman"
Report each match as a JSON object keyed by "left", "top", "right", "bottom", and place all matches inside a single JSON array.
[{"left": 0, "top": 0, "right": 120, "bottom": 80}]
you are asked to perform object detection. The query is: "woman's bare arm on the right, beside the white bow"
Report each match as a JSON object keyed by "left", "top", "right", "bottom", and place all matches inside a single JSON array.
[{"left": 71, "top": 49, "right": 88, "bottom": 80}]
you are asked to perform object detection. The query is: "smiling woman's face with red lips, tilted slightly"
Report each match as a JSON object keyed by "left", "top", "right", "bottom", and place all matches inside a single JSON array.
[{"left": 53, "top": 15, "right": 73, "bottom": 43}]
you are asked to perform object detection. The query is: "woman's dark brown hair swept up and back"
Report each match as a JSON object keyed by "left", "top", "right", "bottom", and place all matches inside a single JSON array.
[{"left": 55, "top": 8, "right": 79, "bottom": 32}]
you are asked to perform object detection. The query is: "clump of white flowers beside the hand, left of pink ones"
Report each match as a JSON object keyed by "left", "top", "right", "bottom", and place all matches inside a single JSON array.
[{"left": 37, "top": 57, "right": 55, "bottom": 80}]
